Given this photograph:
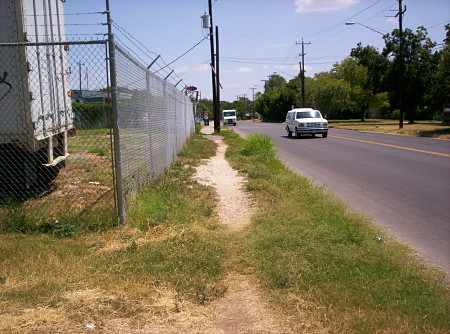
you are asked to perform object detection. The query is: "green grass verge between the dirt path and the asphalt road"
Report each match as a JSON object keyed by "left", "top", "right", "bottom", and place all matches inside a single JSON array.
[{"left": 223, "top": 131, "right": 450, "bottom": 333}]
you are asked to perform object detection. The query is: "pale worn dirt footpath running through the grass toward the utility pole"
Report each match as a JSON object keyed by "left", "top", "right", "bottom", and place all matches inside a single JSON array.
[{"left": 187, "top": 127, "right": 287, "bottom": 334}]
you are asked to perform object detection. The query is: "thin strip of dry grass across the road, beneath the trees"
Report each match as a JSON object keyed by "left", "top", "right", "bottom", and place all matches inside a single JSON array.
[{"left": 330, "top": 119, "right": 450, "bottom": 139}]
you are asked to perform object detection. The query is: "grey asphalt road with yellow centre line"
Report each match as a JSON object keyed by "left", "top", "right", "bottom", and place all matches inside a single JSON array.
[{"left": 233, "top": 121, "right": 450, "bottom": 274}]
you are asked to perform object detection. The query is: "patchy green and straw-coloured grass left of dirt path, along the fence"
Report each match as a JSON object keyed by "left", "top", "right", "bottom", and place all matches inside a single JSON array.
[{"left": 0, "top": 132, "right": 226, "bottom": 333}]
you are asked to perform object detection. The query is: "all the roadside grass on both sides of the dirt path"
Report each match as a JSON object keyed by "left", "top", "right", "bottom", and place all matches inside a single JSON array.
[{"left": 0, "top": 127, "right": 450, "bottom": 333}]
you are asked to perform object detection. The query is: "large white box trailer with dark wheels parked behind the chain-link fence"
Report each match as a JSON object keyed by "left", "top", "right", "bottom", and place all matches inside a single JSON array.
[{"left": 0, "top": 0, "right": 73, "bottom": 200}]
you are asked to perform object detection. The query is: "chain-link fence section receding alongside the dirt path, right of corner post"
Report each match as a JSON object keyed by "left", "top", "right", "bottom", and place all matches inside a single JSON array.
[{"left": 116, "top": 46, "right": 195, "bottom": 195}]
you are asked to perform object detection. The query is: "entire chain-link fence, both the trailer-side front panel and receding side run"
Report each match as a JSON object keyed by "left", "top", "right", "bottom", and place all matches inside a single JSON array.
[{"left": 0, "top": 28, "right": 195, "bottom": 227}]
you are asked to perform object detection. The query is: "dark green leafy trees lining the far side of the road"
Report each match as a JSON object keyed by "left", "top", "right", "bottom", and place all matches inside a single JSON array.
[{"left": 253, "top": 24, "right": 450, "bottom": 123}]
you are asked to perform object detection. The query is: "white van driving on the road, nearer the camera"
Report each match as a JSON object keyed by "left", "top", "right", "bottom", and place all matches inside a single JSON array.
[{"left": 286, "top": 108, "right": 328, "bottom": 138}]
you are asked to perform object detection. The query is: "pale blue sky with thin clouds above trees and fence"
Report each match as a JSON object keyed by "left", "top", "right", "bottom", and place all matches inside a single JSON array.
[{"left": 65, "top": 0, "right": 450, "bottom": 101}]
